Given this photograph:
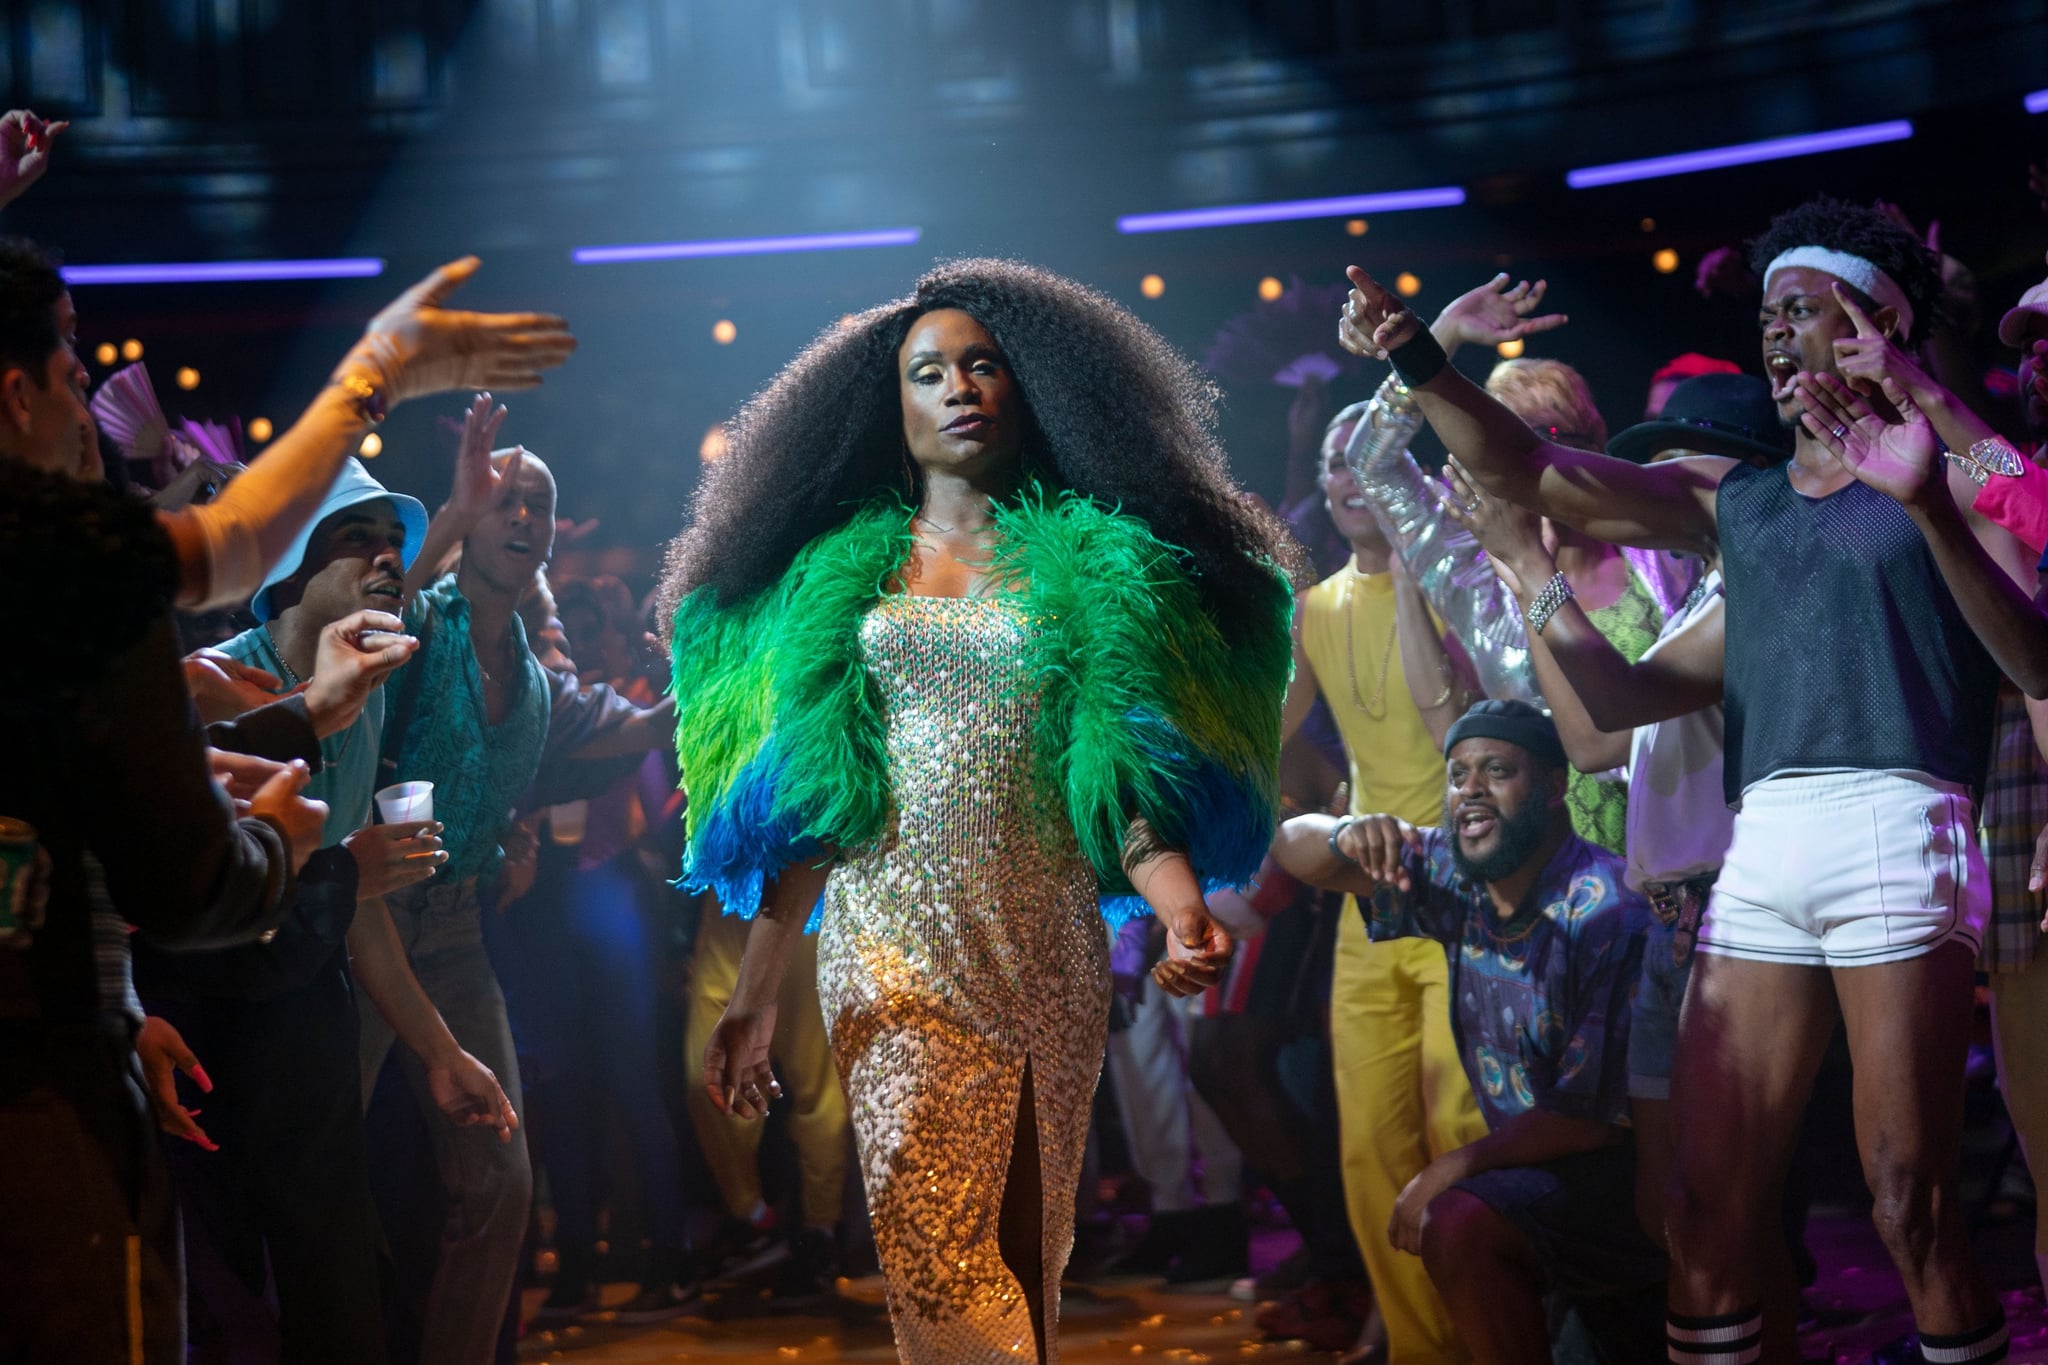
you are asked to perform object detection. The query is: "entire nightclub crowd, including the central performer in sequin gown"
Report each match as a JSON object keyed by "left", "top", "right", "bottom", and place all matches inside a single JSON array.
[{"left": 0, "top": 101, "right": 2048, "bottom": 1365}]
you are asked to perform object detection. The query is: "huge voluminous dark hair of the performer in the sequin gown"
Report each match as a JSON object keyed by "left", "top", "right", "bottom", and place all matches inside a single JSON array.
[{"left": 662, "top": 260, "right": 1300, "bottom": 641}]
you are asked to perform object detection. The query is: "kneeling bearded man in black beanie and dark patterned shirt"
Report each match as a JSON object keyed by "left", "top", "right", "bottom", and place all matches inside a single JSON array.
[{"left": 1274, "top": 702, "right": 1667, "bottom": 1365}]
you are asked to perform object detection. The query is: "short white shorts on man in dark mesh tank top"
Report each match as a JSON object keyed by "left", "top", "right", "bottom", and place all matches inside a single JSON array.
[{"left": 1698, "top": 772, "right": 1991, "bottom": 968}]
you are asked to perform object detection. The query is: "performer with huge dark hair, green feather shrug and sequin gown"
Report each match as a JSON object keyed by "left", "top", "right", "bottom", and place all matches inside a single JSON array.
[{"left": 668, "top": 262, "right": 1290, "bottom": 1365}]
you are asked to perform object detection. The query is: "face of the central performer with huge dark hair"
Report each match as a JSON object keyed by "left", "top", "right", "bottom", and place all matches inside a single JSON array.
[{"left": 897, "top": 309, "right": 1024, "bottom": 477}]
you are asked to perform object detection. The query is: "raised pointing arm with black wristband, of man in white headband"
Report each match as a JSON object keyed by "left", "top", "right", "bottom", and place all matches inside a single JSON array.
[{"left": 1337, "top": 266, "right": 1735, "bottom": 557}]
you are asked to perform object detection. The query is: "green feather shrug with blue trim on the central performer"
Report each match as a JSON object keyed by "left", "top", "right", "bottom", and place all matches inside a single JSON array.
[{"left": 674, "top": 487, "right": 1292, "bottom": 921}]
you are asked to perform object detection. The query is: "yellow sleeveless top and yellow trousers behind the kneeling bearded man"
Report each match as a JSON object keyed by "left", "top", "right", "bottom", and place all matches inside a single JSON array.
[{"left": 1300, "top": 565, "right": 1487, "bottom": 1365}]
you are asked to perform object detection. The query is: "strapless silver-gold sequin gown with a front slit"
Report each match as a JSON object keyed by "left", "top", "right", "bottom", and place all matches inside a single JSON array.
[{"left": 817, "top": 596, "right": 1110, "bottom": 1365}]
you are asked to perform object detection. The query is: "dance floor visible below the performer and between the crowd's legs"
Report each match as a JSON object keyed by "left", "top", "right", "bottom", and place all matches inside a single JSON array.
[{"left": 520, "top": 1209, "right": 2048, "bottom": 1365}]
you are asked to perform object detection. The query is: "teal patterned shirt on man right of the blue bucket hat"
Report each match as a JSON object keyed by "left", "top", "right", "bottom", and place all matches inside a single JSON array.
[{"left": 377, "top": 573, "right": 549, "bottom": 880}]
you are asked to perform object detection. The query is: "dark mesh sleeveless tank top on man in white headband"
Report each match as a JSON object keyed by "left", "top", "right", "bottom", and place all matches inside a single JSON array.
[{"left": 1714, "top": 465, "right": 1999, "bottom": 804}]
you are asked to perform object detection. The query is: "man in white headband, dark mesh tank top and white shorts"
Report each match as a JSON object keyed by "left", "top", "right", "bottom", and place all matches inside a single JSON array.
[{"left": 1339, "top": 199, "right": 2034, "bottom": 1365}]
